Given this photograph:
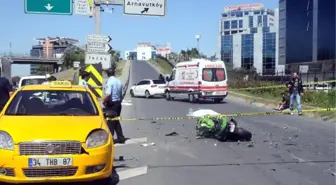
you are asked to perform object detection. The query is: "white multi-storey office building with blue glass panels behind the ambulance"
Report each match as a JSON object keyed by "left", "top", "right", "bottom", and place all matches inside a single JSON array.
[{"left": 219, "top": 4, "right": 284, "bottom": 75}]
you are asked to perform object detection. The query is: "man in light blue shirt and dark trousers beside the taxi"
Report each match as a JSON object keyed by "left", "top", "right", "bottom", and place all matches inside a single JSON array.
[{"left": 103, "top": 67, "right": 126, "bottom": 144}]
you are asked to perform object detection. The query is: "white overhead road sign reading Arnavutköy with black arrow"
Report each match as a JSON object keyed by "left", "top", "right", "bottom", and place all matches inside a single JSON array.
[{"left": 124, "top": 0, "right": 166, "bottom": 16}]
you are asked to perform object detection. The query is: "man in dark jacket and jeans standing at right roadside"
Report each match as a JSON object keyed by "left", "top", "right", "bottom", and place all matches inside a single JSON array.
[{"left": 288, "top": 72, "right": 304, "bottom": 115}]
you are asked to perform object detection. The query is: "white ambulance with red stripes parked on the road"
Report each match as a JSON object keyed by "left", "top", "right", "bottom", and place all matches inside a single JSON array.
[{"left": 165, "top": 59, "right": 228, "bottom": 103}]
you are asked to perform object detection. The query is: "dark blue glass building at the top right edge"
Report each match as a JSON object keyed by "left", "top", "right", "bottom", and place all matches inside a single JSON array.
[{"left": 279, "top": 0, "right": 336, "bottom": 72}]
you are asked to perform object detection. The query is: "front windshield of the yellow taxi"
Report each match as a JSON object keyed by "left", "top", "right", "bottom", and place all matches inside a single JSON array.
[{"left": 5, "top": 90, "right": 98, "bottom": 116}]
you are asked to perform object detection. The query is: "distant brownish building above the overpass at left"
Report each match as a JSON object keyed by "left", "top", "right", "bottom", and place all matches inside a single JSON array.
[{"left": 30, "top": 37, "right": 79, "bottom": 75}]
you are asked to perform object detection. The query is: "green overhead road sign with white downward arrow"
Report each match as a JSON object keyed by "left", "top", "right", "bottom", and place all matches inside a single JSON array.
[{"left": 24, "top": 0, "right": 72, "bottom": 15}]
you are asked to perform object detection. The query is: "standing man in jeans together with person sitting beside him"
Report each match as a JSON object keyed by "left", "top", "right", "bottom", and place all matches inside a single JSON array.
[{"left": 276, "top": 72, "right": 304, "bottom": 115}]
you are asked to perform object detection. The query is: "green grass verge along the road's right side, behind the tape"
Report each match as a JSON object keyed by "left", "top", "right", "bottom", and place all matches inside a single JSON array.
[{"left": 230, "top": 82, "right": 336, "bottom": 121}]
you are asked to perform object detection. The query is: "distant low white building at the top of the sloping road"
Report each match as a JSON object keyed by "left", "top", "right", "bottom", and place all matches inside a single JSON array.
[{"left": 125, "top": 42, "right": 172, "bottom": 60}]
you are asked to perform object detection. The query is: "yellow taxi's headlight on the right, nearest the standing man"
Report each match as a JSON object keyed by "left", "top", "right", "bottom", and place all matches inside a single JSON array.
[{"left": 86, "top": 130, "right": 109, "bottom": 148}]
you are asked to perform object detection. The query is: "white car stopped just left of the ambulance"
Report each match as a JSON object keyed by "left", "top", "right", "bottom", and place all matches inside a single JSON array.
[{"left": 130, "top": 79, "right": 166, "bottom": 98}]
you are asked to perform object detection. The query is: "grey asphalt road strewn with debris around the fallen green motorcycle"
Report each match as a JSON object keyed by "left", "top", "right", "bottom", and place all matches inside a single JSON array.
[{"left": 116, "top": 61, "right": 336, "bottom": 185}]
